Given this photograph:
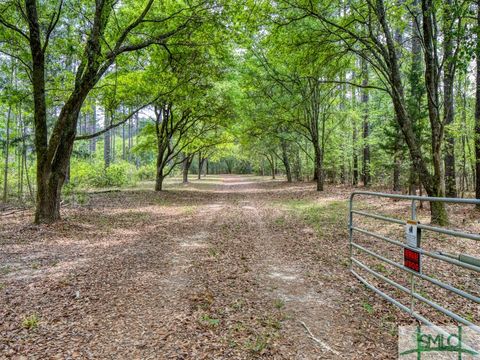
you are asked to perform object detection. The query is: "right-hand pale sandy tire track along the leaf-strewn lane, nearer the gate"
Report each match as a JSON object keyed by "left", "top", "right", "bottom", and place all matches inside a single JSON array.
[{"left": 233, "top": 194, "right": 342, "bottom": 359}]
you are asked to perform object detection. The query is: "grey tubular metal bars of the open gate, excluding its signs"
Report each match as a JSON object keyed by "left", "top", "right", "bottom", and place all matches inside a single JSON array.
[{"left": 349, "top": 191, "right": 480, "bottom": 333}]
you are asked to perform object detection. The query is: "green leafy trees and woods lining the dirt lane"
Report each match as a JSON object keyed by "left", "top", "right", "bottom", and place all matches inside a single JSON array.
[{"left": 0, "top": 0, "right": 480, "bottom": 223}]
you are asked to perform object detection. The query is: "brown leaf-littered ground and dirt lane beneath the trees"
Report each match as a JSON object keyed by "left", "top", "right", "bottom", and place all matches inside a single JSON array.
[{"left": 0, "top": 175, "right": 480, "bottom": 359}]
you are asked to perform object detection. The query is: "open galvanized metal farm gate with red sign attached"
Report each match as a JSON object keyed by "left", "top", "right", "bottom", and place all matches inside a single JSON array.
[{"left": 349, "top": 191, "right": 480, "bottom": 333}]
